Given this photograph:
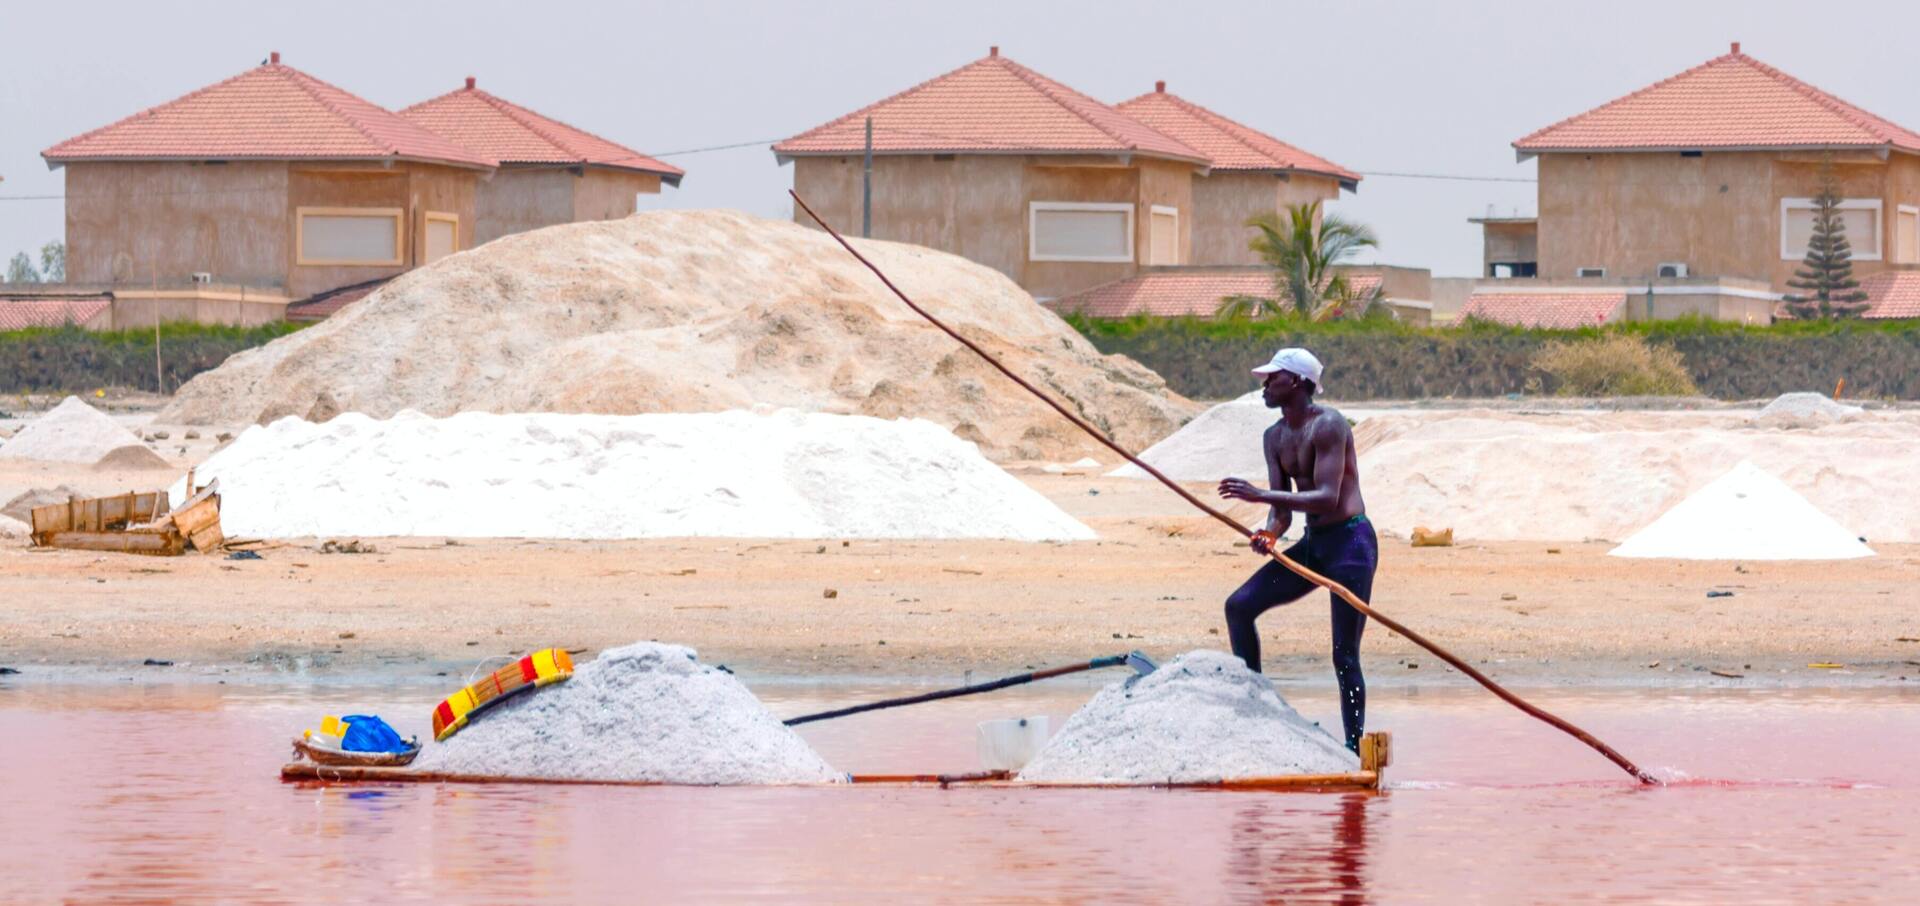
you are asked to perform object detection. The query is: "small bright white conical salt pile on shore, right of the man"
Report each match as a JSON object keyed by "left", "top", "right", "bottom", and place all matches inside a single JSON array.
[{"left": 1607, "top": 461, "right": 1874, "bottom": 560}]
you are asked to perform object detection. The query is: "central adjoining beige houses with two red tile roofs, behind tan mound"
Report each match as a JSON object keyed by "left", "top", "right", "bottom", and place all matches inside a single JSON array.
[{"left": 774, "top": 48, "right": 1359, "bottom": 299}]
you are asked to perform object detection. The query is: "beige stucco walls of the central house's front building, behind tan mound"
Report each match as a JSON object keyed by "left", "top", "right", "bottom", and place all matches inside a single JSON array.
[{"left": 793, "top": 155, "right": 1194, "bottom": 298}]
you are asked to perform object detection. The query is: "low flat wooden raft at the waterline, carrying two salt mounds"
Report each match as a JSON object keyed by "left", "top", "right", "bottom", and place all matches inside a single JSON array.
[{"left": 280, "top": 733, "right": 1394, "bottom": 793}]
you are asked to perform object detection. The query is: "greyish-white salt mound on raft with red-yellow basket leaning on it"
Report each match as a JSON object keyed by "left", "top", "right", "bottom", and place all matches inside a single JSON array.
[{"left": 413, "top": 643, "right": 845, "bottom": 783}]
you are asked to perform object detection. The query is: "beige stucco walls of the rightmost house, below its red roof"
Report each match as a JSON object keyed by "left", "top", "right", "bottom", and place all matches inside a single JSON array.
[{"left": 1540, "top": 152, "right": 1920, "bottom": 292}]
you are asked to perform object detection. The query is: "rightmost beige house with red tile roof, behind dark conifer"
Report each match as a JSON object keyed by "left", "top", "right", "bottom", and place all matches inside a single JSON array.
[{"left": 1486, "top": 44, "right": 1920, "bottom": 322}]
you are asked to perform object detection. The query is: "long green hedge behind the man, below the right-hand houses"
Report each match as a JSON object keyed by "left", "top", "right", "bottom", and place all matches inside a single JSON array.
[{"left": 1068, "top": 317, "right": 1920, "bottom": 399}]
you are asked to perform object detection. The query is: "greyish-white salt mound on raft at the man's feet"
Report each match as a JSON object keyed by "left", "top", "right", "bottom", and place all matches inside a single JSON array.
[{"left": 1020, "top": 651, "right": 1359, "bottom": 783}]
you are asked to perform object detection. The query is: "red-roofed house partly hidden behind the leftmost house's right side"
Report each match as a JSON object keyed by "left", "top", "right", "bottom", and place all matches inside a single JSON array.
[{"left": 399, "top": 77, "right": 685, "bottom": 244}]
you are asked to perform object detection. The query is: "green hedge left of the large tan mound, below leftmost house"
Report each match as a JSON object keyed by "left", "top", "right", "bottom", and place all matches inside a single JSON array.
[{"left": 0, "top": 322, "right": 305, "bottom": 393}]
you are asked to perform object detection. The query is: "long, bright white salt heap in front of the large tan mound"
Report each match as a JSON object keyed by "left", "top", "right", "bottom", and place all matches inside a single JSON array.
[{"left": 173, "top": 409, "right": 1094, "bottom": 541}]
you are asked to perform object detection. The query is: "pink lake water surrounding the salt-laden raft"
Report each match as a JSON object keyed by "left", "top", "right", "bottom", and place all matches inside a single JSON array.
[{"left": 0, "top": 683, "right": 1920, "bottom": 906}]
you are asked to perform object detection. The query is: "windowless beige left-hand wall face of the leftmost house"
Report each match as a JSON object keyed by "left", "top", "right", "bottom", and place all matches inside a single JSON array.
[{"left": 65, "top": 161, "right": 292, "bottom": 286}]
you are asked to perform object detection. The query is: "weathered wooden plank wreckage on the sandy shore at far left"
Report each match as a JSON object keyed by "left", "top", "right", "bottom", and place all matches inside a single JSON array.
[{"left": 33, "top": 472, "right": 227, "bottom": 557}]
